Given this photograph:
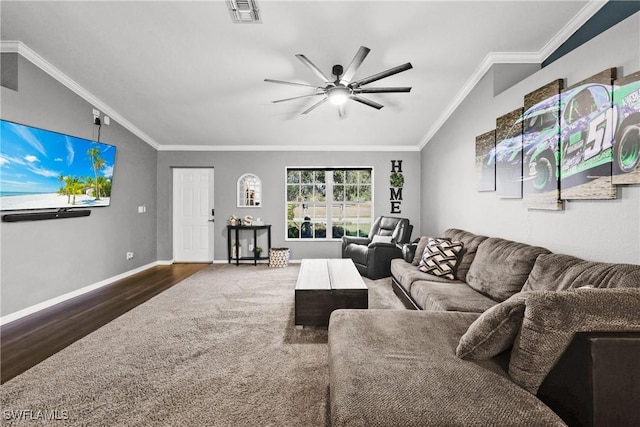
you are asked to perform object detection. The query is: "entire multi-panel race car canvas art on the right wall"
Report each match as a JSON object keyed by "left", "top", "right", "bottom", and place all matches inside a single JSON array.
[{"left": 475, "top": 68, "right": 640, "bottom": 210}]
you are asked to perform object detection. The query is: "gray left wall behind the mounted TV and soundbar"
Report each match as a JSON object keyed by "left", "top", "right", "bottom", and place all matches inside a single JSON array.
[{"left": 0, "top": 54, "right": 157, "bottom": 316}]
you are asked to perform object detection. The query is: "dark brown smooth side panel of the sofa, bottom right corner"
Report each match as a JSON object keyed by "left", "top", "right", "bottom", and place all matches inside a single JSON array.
[{"left": 537, "top": 332, "right": 640, "bottom": 426}]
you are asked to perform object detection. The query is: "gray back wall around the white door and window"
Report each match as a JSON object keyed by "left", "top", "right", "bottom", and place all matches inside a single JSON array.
[{"left": 158, "top": 151, "right": 420, "bottom": 260}]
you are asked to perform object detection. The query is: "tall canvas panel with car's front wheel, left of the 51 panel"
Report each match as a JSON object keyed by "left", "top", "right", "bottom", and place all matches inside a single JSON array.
[{"left": 522, "top": 80, "right": 563, "bottom": 210}]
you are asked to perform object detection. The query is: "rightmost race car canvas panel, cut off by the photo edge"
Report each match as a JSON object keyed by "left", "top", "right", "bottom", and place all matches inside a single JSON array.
[{"left": 613, "top": 72, "right": 640, "bottom": 184}]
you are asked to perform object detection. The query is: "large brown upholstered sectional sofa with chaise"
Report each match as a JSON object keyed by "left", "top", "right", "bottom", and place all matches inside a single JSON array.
[{"left": 329, "top": 229, "right": 640, "bottom": 426}]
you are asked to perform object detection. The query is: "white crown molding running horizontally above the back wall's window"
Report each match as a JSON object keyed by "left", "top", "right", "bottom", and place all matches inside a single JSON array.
[{"left": 158, "top": 145, "right": 420, "bottom": 152}]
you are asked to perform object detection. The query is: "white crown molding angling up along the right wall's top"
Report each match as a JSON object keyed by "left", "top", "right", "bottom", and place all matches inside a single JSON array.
[{"left": 418, "top": 0, "right": 608, "bottom": 150}]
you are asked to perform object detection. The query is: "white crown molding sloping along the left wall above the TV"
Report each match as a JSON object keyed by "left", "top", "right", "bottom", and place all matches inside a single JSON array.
[{"left": 0, "top": 40, "right": 160, "bottom": 150}]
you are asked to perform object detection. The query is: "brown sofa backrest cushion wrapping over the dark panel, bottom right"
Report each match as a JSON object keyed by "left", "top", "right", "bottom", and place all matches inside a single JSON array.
[{"left": 509, "top": 288, "right": 640, "bottom": 394}]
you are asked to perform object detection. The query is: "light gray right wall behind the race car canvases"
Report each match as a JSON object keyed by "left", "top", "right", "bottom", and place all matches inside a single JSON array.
[{"left": 421, "top": 13, "right": 640, "bottom": 264}]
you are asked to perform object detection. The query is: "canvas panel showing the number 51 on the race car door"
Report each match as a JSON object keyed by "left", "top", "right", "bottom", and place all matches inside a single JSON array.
[{"left": 560, "top": 68, "right": 616, "bottom": 200}]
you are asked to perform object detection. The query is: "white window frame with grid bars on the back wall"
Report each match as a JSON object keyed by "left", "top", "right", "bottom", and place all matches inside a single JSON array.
[{"left": 284, "top": 166, "right": 375, "bottom": 242}]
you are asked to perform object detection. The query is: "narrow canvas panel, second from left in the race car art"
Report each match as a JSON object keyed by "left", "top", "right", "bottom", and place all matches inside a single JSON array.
[{"left": 494, "top": 108, "right": 523, "bottom": 199}]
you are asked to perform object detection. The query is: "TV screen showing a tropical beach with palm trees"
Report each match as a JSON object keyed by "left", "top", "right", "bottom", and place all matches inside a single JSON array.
[{"left": 0, "top": 120, "right": 116, "bottom": 211}]
